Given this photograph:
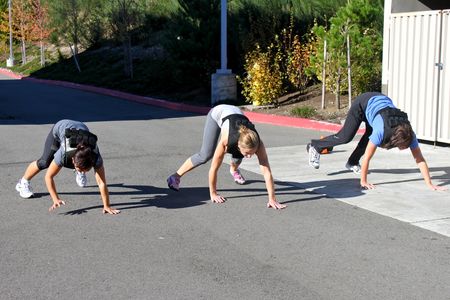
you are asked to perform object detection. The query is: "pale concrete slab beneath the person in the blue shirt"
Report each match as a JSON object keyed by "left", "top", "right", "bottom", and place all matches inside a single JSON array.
[{"left": 242, "top": 142, "right": 450, "bottom": 236}]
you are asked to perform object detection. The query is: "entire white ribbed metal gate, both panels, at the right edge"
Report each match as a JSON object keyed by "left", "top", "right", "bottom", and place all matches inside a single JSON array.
[{"left": 387, "top": 10, "right": 450, "bottom": 143}]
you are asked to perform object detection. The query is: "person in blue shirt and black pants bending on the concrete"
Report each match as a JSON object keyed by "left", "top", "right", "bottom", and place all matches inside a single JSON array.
[{"left": 306, "top": 92, "right": 446, "bottom": 190}]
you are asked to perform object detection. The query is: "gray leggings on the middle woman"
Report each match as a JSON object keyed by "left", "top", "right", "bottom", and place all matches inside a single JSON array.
[{"left": 190, "top": 110, "right": 242, "bottom": 168}]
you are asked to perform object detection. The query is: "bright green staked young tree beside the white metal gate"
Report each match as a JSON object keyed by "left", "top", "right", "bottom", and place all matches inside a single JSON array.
[{"left": 310, "top": 0, "right": 383, "bottom": 105}]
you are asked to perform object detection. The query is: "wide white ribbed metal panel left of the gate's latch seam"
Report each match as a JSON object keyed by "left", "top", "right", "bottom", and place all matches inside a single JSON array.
[{"left": 388, "top": 11, "right": 441, "bottom": 141}]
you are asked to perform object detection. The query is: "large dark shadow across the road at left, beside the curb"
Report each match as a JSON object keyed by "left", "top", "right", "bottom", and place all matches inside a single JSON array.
[{"left": 0, "top": 80, "right": 202, "bottom": 125}]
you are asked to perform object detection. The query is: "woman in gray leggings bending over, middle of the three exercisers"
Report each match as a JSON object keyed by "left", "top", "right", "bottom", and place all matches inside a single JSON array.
[{"left": 167, "top": 104, "right": 286, "bottom": 209}]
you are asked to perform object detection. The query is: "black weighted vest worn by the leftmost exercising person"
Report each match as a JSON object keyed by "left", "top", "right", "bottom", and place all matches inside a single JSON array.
[{"left": 63, "top": 128, "right": 98, "bottom": 169}]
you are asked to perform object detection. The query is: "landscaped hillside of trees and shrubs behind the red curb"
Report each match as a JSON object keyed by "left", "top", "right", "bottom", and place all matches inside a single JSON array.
[{"left": 0, "top": 0, "right": 382, "bottom": 108}]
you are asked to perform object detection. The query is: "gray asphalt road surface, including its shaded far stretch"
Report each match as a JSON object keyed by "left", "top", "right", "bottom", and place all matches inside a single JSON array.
[{"left": 0, "top": 75, "right": 450, "bottom": 299}]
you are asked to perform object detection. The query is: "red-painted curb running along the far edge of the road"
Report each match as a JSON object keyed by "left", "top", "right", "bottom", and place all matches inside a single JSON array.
[{"left": 0, "top": 68, "right": 364, "bottom": 134}]
